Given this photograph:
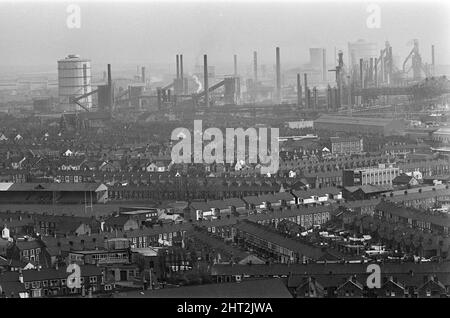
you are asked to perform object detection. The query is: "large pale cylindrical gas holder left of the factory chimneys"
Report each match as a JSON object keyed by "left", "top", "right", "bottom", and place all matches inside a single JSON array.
[{"left": 58, "top": 54, "right": 92, "bottom": 111}]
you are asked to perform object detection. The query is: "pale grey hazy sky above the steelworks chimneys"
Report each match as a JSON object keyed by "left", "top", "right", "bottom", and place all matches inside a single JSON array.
[{"left": 0, "top": 0, "right": 450, "bottom": 72}]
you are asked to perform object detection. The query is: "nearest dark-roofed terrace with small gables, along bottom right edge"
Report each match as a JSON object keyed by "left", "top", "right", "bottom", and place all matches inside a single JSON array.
[{"left": 211, "top": 262, "right": 450, "bottom": 298}]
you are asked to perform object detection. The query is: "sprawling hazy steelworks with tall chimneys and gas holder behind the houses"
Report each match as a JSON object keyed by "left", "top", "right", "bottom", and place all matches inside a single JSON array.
[{"left": 40, "top": 36, "right": 450, "bottom": 132}]
